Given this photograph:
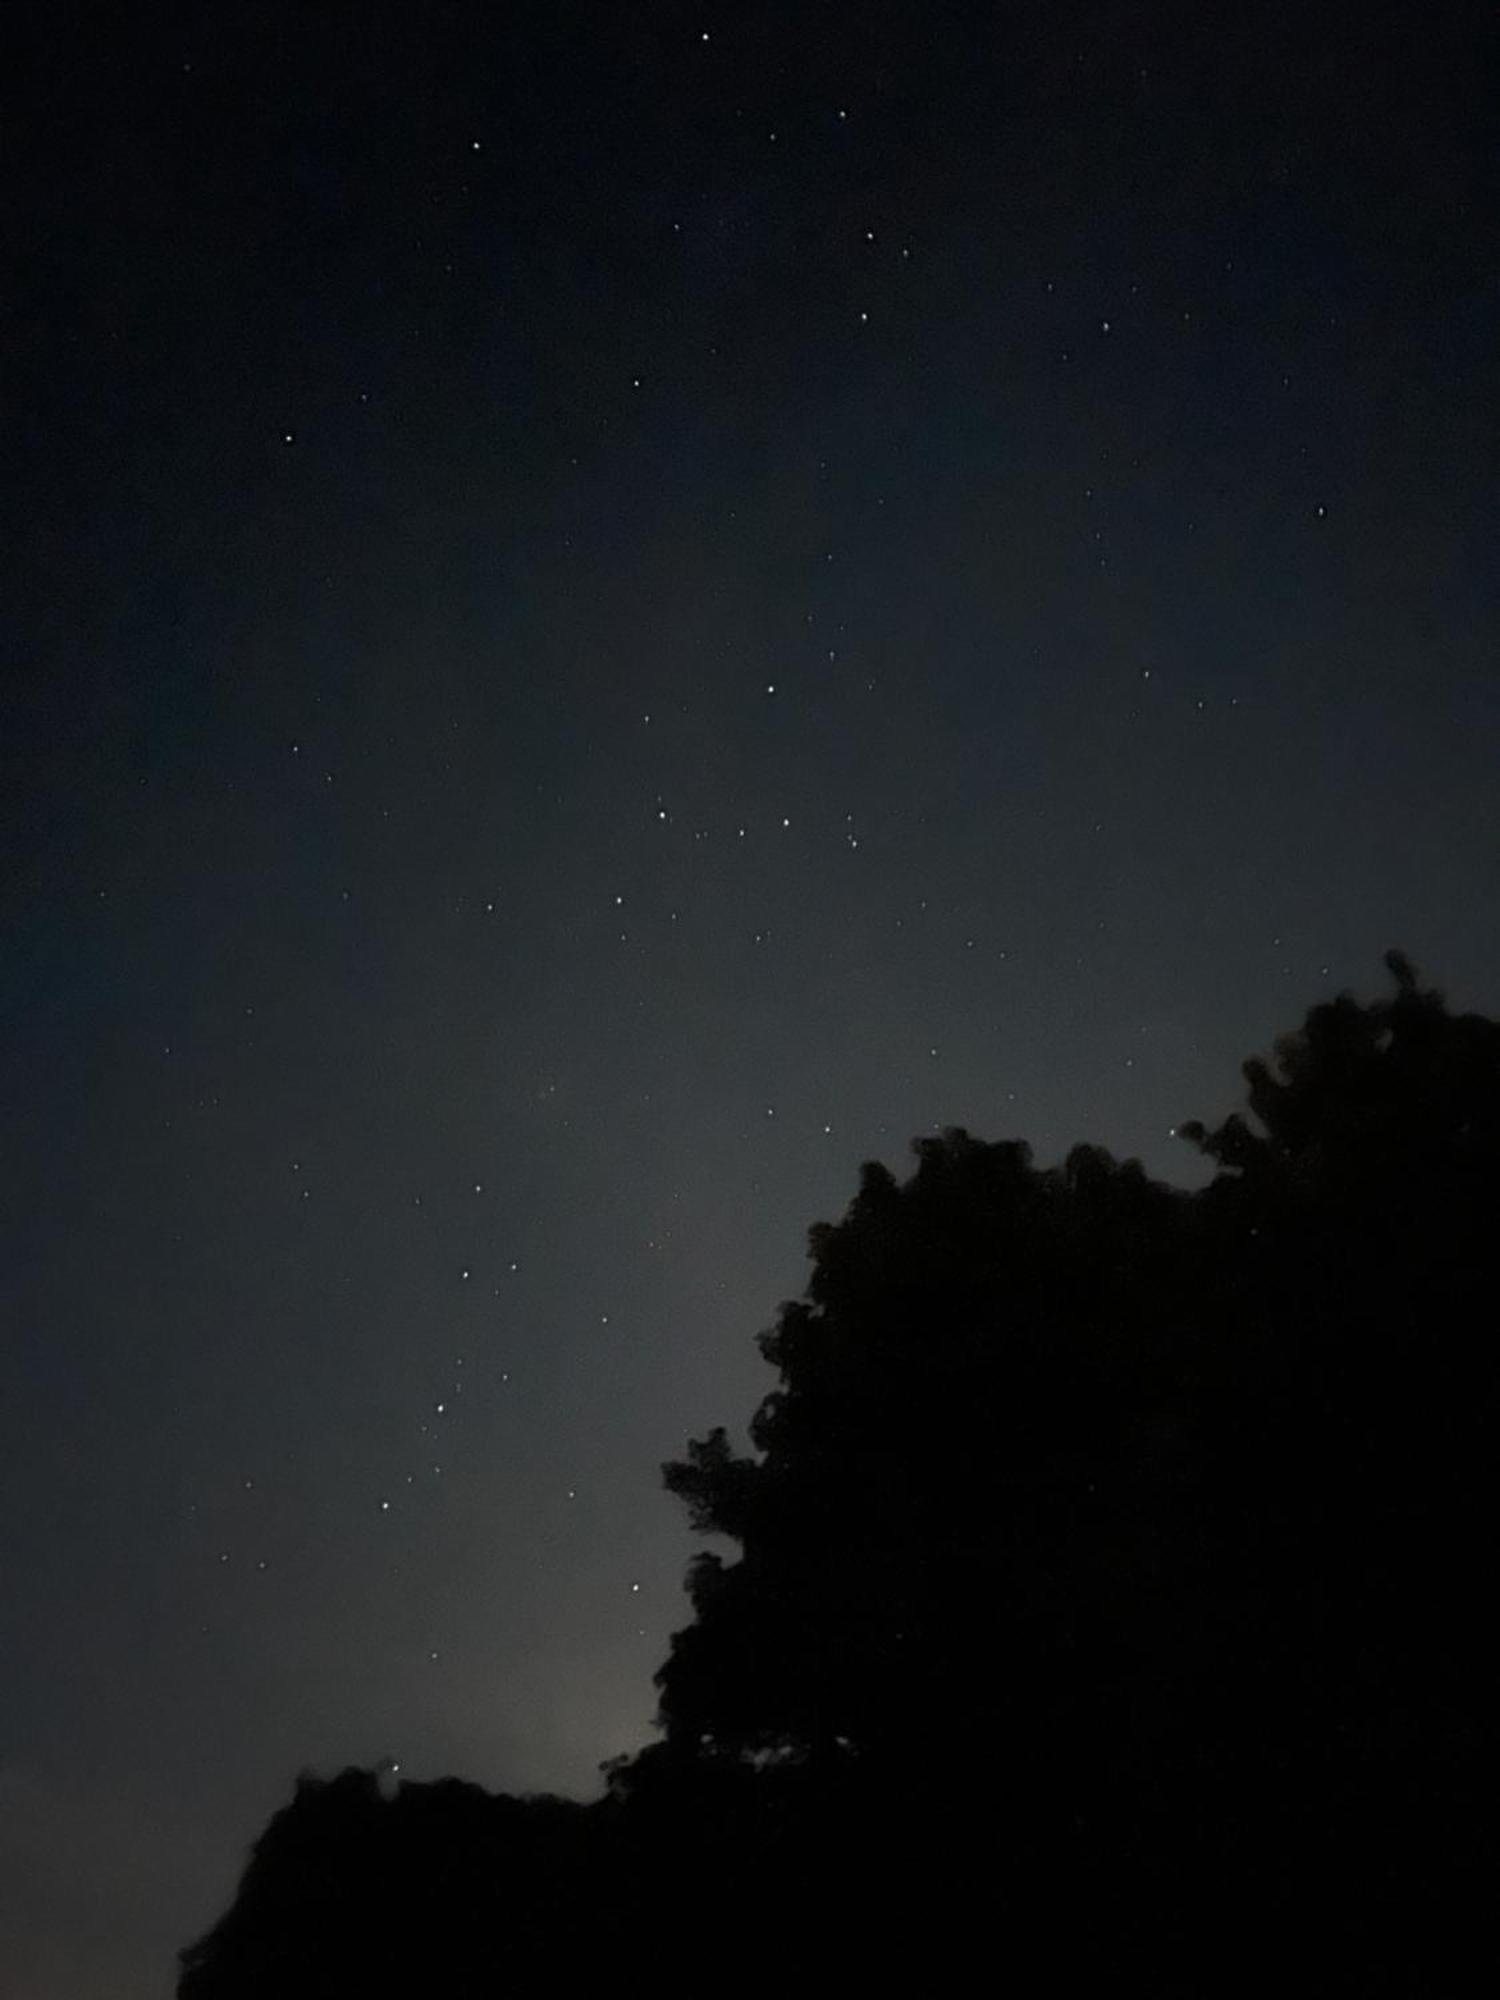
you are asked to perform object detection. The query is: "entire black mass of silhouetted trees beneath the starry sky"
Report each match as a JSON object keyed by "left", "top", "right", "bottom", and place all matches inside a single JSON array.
[{"left": 182, "top": 952, "right": 1500, "bottom": 2000}]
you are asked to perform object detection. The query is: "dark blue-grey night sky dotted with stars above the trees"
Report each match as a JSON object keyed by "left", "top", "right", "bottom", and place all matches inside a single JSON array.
[{"left": 0, "top": 0, "right": 1500, "bottom": 2000}]
